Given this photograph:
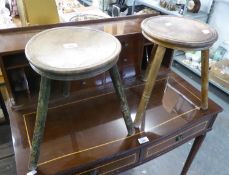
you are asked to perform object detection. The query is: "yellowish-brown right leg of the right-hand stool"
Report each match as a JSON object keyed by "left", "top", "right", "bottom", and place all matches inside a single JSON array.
[{"left": 201, "top": 49, "right": 209, "bottom": 110}]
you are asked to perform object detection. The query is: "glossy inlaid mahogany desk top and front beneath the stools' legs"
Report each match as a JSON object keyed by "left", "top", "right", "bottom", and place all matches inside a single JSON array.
[{"left": 8, "top": 73, "right": 222, "bottom": 175}]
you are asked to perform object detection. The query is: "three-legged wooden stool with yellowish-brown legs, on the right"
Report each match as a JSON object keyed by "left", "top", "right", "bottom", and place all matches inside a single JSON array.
[{"left": 134, "top": 15, "right": 218, "bottom": 127}]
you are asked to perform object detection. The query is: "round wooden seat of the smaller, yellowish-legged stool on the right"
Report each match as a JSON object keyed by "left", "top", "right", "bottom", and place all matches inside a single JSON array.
[{"left": 141, "top": 15, "right": 218, "bottom": 50}]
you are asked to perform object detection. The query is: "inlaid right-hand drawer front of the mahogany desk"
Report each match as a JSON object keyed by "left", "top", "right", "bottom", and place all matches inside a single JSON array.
[{"left": 143, "top": 121, "right": 208, "bottom": 160}]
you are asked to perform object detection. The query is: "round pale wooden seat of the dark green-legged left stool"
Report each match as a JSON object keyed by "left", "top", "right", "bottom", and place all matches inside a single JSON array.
[{"left": 25, "top": 27, "right": 121, "bottom": 80}]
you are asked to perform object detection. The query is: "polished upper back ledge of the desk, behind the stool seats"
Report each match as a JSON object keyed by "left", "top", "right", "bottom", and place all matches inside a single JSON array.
[{"left": 0, "top": 13, "right": 157, "bottom": 55}]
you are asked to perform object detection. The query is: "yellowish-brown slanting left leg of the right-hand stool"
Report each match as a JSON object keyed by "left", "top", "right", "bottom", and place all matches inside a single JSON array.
[{"left": 134, "top": 45, "right": 166, "bottom": 128}]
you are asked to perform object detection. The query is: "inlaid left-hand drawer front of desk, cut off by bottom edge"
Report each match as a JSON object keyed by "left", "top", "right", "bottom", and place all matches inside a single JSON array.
[{"left": 75, "top": 152, "right": 139, "bottom": 175}]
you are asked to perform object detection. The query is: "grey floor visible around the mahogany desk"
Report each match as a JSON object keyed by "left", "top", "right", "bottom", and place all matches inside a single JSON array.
[{"left": 0, "top": 64, "right": 229, "bottom": 175}]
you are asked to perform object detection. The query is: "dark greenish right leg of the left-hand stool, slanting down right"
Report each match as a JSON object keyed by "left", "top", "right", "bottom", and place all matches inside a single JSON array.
[{"left": 109, "top": 65, "right": 134, "bottom": 135}]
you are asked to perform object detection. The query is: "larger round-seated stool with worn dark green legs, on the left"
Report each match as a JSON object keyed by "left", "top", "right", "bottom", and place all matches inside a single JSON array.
[{"left": 25, "top": 27, "right": 134, "bottom": 171}]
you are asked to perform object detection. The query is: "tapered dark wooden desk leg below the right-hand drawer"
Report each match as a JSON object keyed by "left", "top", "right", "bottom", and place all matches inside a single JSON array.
[{"left": 181, "top": 134, "right": 206, "bottom": 175}]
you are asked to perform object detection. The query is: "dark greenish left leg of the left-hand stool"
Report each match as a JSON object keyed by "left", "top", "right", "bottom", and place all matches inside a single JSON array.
[{"left": 29, "top": 76, "right": 51, "bottom": 170}]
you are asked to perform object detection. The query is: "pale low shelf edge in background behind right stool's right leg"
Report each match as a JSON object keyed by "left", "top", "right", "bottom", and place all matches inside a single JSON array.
[{"left": 173, "top": 55, "right": 229, "bottom": 95}]
